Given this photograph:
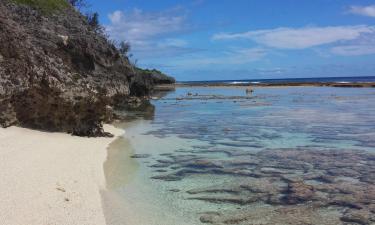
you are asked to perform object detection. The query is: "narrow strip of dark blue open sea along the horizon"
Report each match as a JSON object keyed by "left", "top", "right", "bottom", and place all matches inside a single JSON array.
[{"left": 180, "top": 76, "right": 375, "bottom": 84}]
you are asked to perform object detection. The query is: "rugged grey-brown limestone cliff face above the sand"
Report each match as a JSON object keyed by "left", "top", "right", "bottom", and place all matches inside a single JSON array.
[{"left": 0, "top": 0, "right": 176, "bottom": 136}]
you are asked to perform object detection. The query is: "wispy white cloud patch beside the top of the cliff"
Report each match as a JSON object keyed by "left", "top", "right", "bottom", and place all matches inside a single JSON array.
[{"left": 106, "top": 7, "right": 201, "bottom": 58}]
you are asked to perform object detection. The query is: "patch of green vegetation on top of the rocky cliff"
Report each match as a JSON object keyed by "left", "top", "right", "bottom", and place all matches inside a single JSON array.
[{"left": 11, "top": 0, "right": 69, "bottom": 14}]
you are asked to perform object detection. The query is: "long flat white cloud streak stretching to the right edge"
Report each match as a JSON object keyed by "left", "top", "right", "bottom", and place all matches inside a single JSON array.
[{"left": 212, "top": 25, "right": 375, "bottom": 49}]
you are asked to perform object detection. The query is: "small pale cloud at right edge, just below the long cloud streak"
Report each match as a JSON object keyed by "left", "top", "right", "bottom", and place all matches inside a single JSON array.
[{"left": 331, "top": 45, "right": 375, "bottom": 56}]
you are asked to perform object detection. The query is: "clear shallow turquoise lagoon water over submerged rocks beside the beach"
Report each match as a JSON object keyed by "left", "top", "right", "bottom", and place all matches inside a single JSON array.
[{"left": 103, "top": 87, "right": 375, "bottom": 225}]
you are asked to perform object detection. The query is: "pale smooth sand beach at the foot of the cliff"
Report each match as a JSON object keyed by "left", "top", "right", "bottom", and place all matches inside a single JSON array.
[{"left": 0, "top": 125, "right": 123, "bottom": 225}]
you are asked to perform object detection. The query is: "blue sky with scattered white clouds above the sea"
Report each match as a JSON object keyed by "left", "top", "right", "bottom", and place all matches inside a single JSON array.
[{"left": 89, "top": 0, "right": 375, "bottom": 81}]
